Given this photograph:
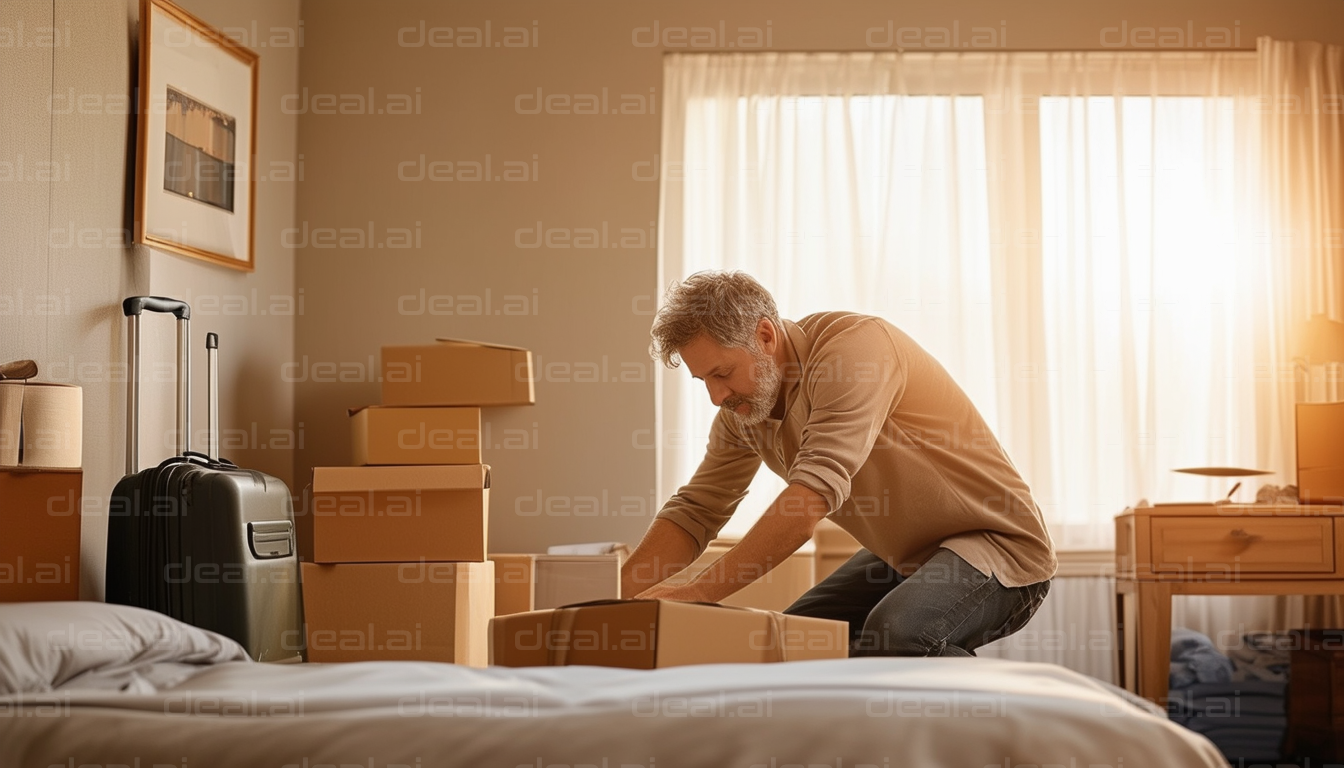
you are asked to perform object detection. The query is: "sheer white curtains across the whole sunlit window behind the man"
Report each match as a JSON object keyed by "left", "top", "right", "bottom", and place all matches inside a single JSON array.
[{"left": 660, "top": 54, "right": 1268, "bottom": 549}]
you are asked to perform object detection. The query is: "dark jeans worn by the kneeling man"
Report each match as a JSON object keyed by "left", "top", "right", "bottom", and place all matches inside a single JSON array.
[{"left": 785, "top": 549, "right": 1050, "bottom": 656}]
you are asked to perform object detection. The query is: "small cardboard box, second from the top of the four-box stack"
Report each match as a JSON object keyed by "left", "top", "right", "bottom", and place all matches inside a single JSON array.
[{"left": 349, "top": 405, "right": 481, "bottom": 467}]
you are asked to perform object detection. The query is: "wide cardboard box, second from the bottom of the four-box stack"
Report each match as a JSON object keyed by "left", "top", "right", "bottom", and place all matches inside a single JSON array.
[{"left": 302, "top": 464, "right": 491, "bottom": 562}]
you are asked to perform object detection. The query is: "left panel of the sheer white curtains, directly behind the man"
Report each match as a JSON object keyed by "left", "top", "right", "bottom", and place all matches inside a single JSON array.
[{"left": 661, "top": 54, "right": 999, "bottom": 535}]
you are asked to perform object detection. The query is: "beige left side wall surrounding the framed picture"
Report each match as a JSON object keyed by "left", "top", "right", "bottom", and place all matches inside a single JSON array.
[{"left": 0, "top": 0, "right": 298, "bottom": 599}]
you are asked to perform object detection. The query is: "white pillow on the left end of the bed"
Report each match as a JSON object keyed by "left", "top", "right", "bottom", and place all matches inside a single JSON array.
[{"left": 0, "top": 601, "right": 247, "bottom": 695}]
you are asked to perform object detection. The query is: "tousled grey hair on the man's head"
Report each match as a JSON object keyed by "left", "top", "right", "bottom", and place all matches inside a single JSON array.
[{"left": 649, "top": 270, "right": 781, "bottom": 369}]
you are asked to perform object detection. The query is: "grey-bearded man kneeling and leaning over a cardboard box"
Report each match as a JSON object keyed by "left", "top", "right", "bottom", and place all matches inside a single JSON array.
[{"left": 621, "top": 272, "right": 1056, "bottom": 656}]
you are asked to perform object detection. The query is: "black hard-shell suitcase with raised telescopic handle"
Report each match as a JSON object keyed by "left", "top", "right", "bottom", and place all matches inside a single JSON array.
[{"left": 106, "top": 296, "right": 304, "bottom": 662}]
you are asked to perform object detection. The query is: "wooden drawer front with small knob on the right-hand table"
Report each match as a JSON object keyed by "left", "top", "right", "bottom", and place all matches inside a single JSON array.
[{"left": 1152, "top": 515, "right": 1335, "bottom": 574}]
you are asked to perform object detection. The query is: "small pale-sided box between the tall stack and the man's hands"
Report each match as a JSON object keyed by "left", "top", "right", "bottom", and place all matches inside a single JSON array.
[{"left": 491, "top": 554, "right": 621, "bottom": 616}]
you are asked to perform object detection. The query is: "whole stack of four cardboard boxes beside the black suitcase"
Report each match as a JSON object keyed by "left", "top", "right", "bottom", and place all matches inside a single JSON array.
[{"left": 298, "top": 340, "right": 535, "bottom": 666}]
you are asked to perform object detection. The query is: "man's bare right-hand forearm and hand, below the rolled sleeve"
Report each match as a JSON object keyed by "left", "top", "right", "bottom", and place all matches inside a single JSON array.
[{"left": 622, "top": 483, "right": 828, "bottom": 603}]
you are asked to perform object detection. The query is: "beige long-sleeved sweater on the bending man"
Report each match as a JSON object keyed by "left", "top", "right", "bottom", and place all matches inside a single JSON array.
[{"left": 659, "top": 312, "right": 1056, "bottom": 586}]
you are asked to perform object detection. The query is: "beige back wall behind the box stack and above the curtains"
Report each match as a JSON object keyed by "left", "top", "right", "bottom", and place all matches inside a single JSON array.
[{"left": 296, "top": 0, "right": 1344, "bottom": 550}]
